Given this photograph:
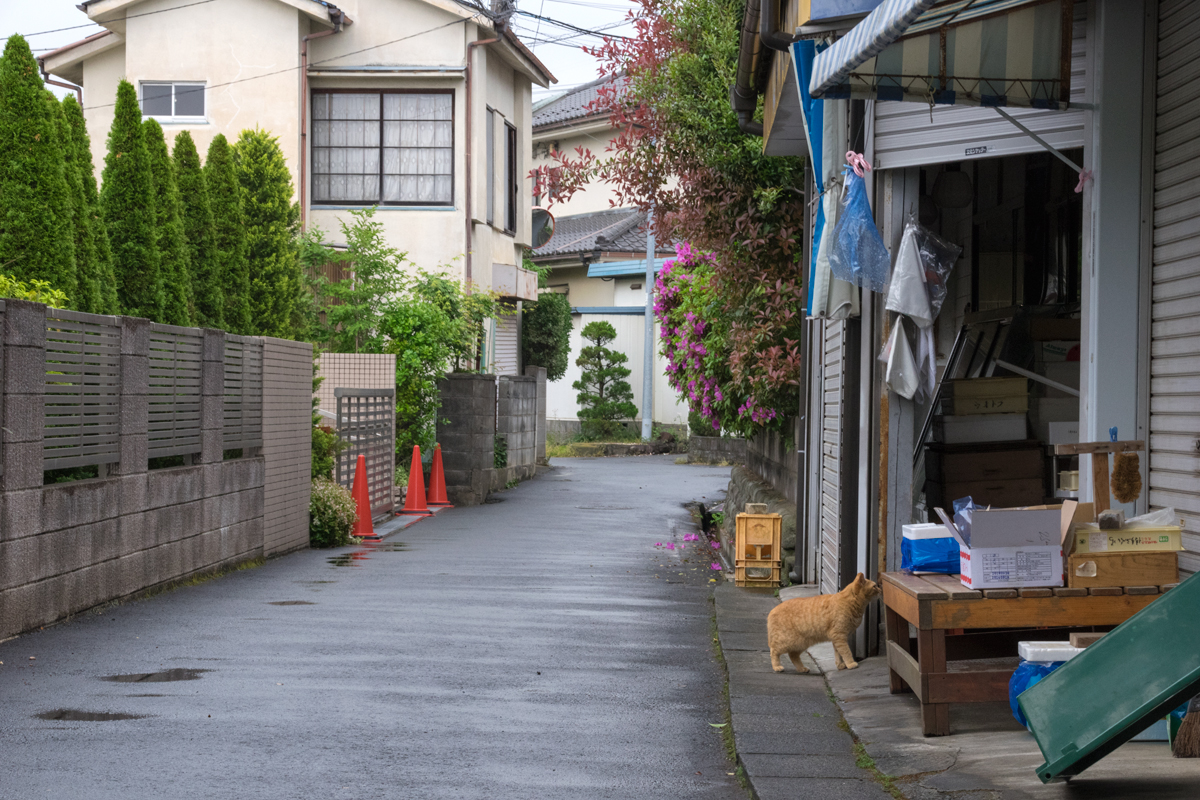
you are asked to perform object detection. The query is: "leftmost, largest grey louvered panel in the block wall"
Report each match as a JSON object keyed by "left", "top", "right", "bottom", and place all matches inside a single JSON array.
[{"left": 42, "top": 308, "right": 121, "bottom": 469}]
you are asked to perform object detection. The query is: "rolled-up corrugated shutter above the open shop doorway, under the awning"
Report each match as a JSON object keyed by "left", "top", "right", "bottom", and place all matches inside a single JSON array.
[{"left": 875, "top": 0, "right": 1087, "bottom": 169}]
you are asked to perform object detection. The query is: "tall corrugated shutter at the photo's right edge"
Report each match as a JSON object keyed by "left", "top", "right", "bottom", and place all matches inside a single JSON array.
[{"left": 1150, "top": 0, "right": 1200, "bottom": 572}]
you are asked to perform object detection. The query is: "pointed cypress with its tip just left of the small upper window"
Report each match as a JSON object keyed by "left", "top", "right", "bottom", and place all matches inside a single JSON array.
[{"left": 100, "top": 80, "right": 163, "bottom": 320}]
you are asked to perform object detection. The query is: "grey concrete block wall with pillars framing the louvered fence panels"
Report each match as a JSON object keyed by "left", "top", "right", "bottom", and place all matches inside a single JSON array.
[{"left": 0, "top": 300, "right": 312, "bottom": 638}]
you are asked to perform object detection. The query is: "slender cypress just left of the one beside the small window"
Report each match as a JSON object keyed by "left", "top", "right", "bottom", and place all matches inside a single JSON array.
[{"left": 62, "top": 95, "right": 120, "bottom": 314}]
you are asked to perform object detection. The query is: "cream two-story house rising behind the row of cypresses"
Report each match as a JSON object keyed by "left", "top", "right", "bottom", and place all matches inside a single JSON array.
[{"left": 42, "top": 0, "right": 554, "bottom": 373}]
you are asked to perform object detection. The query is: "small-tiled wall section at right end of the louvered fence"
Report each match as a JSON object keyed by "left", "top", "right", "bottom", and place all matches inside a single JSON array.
[{"left": 263, "top": 338, "right": 314, "bottom": 555}]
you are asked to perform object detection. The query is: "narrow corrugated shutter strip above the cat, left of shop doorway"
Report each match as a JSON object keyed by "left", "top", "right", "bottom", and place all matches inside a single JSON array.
[{"left": 821, "top": 320, "right": 846, "bottom": 594}]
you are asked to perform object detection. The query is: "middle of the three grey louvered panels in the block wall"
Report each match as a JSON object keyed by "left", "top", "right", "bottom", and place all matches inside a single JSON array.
[{"left": 149, "top": 324, "right": 204, "bottom": 458}]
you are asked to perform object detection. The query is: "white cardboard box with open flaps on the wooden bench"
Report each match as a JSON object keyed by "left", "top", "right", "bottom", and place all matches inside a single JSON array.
[{"left": 937, "top": 500, "right": 1079, "bottom": 589}]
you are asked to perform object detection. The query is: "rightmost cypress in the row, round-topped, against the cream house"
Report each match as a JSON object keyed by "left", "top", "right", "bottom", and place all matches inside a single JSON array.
[{"left": 233, "top": 128, "right": 304, "bottom": 339}]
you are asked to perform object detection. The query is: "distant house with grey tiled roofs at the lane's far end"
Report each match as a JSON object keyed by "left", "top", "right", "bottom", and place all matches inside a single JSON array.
[{"left": 533, "top": 78, "right": 688, "bottom": 432}]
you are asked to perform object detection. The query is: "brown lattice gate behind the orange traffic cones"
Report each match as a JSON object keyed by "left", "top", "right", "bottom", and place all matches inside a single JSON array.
[{"left": 334, "top": 389, "right": 396, "bottom": 517}]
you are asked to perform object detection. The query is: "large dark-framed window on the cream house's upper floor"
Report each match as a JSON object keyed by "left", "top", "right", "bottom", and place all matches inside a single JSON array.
[{"left": 312, "top": 91, "right": 454, "bottom": 205}]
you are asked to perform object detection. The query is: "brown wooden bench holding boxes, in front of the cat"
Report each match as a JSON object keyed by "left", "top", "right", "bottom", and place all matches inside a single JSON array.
[{"left": 883, "top": 572, "right": 1175, "bottom": 736}]
